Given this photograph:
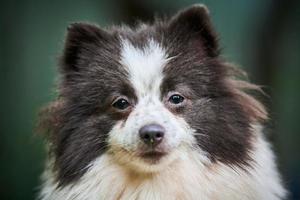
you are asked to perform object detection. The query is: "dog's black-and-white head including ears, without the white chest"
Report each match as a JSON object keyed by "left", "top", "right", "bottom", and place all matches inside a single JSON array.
[{"left": 43, "top": 6, "right": 263, "bottom": 184}]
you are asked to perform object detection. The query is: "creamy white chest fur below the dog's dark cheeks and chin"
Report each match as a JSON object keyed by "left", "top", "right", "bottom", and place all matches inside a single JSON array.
[{"left": 41, "top": 124, "right": 286, "bottom": 200}]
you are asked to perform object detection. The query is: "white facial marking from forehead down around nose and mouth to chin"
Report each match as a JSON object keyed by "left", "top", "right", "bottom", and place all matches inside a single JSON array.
[{"left": 109, "top": 40, "right": 194, "bottom": 171}]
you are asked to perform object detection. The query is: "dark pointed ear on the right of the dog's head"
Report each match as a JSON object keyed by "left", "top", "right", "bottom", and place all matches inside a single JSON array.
[{"left": 169, "top": 4, "right": 219, "bottom": 57}]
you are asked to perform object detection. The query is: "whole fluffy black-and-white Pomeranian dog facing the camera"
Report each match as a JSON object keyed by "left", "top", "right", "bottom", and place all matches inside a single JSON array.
[{"left": 39, "top": 5, "right": 286, "bottom": 200}]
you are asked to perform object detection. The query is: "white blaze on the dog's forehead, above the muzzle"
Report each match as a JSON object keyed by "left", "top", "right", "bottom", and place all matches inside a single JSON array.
[{"left": 121, "top": 39, "right": 168, "bottom": 97}]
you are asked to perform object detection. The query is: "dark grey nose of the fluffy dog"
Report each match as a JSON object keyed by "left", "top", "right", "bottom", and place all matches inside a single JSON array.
[{"left": 139, "top": 124, "right": 165, "bottom": 146}]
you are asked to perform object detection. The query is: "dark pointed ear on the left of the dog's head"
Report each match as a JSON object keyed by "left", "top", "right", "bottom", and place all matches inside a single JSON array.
[{"left": 61, "top": 23, "right": 110, "bottom": 72}]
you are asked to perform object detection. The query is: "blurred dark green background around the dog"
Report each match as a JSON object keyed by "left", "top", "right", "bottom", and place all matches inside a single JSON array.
[{"left": 0, "top": 0, "right": 300, "bottom": 200}]
